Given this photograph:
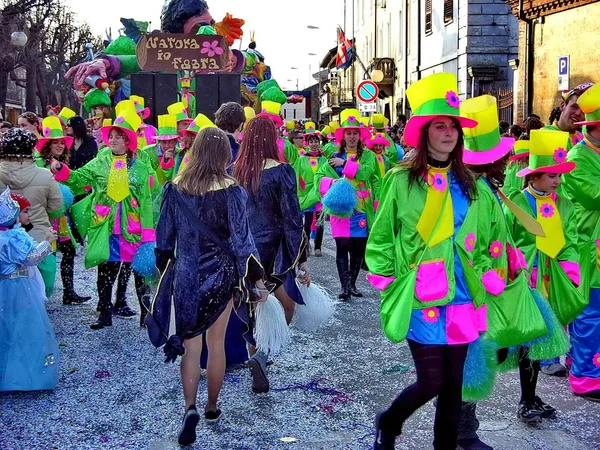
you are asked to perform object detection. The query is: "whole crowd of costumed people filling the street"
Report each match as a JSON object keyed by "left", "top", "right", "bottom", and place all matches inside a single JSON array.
[{"left": 0, "top": 73, "right": 600, "bottom": 450}]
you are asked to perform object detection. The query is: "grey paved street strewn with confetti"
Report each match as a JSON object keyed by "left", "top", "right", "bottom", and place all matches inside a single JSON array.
[{"left": 0, "top": 230, "right": 600, "bottom": 450}]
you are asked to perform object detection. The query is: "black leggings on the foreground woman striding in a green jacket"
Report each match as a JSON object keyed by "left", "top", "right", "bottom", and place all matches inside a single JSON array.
[{"left": 380, "top": 339, "right": 469, "bottom": 450}]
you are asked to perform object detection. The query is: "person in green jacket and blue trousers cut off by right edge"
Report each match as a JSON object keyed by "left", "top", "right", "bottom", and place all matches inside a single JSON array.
[{"left": 563, "top": 84, "right": 600, "bottom": 401}]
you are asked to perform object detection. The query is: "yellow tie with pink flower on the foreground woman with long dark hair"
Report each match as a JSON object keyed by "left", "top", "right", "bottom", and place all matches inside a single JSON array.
[{"left": 417, "top": 166, "right": 454, "bottom": 247}]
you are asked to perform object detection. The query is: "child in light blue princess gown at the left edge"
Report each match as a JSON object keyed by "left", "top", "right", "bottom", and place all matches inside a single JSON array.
[{"left": 0, "top": 188, "right": 60, "bottom": 392}]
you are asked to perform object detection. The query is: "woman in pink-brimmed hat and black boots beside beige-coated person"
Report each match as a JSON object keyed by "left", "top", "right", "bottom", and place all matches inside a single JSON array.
[{"left": 36, "top": 116, "right": 91, "bottom": 305}]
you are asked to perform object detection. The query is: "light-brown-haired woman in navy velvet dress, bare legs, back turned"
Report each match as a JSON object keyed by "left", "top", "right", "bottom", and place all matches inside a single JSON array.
[{"left": 149, "top": 128, "right": 267, "bottom": 445}]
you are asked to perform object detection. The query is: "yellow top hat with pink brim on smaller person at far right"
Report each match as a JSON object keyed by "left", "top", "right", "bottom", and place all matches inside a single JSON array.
[{"left": 517, "top": 130, "right": 575, "bottom": 177}]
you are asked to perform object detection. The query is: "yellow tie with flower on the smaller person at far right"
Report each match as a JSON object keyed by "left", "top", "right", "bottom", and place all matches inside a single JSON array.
[{"left": 527, "top": 187, "right": 566, "bottom": 259}]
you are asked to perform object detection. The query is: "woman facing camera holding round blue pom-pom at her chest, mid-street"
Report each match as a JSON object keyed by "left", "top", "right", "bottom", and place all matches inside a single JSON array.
[{"left": 314, "top": 109, "right": 380, "bottom": 300}]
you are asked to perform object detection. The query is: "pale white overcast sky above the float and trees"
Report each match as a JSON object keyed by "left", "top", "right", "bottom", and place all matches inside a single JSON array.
[{"left": 66, "top": 0, "right": 344, "bottom": 90}]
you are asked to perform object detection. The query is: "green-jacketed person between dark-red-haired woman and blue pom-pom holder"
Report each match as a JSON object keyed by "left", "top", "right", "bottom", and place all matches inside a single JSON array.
[{"left": 293, "top": 122, "right": 327, "bottom": 256}]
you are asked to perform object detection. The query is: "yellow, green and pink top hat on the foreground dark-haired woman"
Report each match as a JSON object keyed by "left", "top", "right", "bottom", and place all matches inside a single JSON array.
[{"left": 404, "top": 73, "right": 477, "bottom": 147}]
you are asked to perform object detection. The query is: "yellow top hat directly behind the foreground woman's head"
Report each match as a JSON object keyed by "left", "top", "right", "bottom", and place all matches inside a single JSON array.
[{"left": 460, "top": 95, "right": 515, "bottom": 165}]
